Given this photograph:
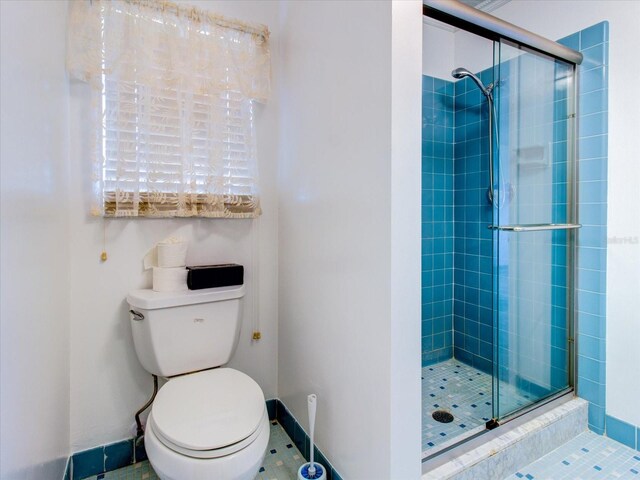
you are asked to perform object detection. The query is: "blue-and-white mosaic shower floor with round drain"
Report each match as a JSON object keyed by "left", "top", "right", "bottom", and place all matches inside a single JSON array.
[{"left": 422, "top": 358, "right": 531, "bottom": 456}]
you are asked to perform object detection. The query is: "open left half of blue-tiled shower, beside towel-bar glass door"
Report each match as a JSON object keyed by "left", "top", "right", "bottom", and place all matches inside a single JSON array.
[{"left": 422, "top": 21, "right": 495, "bottom": 458}]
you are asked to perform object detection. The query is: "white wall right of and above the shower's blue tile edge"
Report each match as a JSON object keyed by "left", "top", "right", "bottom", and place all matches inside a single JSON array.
[{"left": 484, "top": 0, "right": 640, "bottom": 425}]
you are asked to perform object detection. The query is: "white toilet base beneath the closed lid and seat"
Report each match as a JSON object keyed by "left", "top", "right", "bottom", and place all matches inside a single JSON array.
[{"left": 144, "top": 408, "right": 270, "bottom": 480}]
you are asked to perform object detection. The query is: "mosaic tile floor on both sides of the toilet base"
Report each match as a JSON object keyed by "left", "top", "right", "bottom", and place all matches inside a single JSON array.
[{"left": 84, "top": 420, "right": 305, "bottom": 480}]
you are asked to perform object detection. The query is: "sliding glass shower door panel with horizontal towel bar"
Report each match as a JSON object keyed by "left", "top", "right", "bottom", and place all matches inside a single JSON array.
[{"left": 490, "top": 41, "right": 577, "bottom": 421}]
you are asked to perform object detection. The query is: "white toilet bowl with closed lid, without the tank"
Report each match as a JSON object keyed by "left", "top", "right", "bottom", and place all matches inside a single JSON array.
[{"left": 145, "top": 368, "right": 269, "bottom": 480}]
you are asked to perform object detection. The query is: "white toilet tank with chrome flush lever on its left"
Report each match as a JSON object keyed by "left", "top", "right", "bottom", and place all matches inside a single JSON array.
[{"left": 127, "top": 285, "right": 244, "bottom": 377}]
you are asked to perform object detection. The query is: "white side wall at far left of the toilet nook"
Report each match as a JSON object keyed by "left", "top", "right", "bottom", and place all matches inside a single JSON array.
[{"left": 0, "top": 1, "right": 69, "bottom": 480}]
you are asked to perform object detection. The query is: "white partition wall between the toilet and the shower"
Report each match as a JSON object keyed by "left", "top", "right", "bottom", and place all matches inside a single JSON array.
[{"left": 278, "top": 1, "right": 421, "bottom": 478}]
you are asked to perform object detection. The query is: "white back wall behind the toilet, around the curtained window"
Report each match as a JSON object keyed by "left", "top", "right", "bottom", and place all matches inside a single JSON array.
[{"left": 69, "top": 0, "right": 279, "bottom": 452}]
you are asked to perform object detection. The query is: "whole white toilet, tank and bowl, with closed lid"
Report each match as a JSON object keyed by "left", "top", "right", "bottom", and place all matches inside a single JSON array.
[{"left": 127, "top": 285, "right": 269, "bottom": 480}]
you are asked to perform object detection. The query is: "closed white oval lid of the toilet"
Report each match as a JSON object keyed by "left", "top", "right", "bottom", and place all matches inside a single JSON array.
[{"left": 151, "top": 368, "right": 265, "bottom": 450}]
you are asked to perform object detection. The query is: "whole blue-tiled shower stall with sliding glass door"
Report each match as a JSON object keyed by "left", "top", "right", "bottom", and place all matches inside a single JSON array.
[{"left": 422, "top": 2, "right": 581, "bottom": 459}]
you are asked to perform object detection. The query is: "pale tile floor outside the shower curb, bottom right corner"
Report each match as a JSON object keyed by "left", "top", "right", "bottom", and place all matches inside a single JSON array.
[{"left": 505, "top": 431, "right": 640, "bottom": 480}]
